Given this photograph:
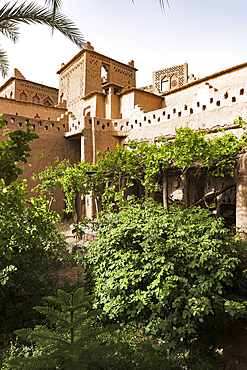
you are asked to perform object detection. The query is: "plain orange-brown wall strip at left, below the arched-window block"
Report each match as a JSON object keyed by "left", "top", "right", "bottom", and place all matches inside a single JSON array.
[{"left": 0, "top": 97, "right": 66, "bottom": 120}]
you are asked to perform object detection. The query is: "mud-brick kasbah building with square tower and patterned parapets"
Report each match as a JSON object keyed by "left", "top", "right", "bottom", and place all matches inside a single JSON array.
[{"left": 0, "top": 42, "right": 247, "bottom": 227}]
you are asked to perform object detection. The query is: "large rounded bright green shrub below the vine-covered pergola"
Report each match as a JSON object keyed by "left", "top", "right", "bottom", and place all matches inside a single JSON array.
[{"left": 85, "top": 200, "right": 247, "bottom": 347}]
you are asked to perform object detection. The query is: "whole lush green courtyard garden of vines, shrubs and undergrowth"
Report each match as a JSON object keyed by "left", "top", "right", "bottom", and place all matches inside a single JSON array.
[{"left": 0, "top": 122, "right": 247, "bottom": 370}]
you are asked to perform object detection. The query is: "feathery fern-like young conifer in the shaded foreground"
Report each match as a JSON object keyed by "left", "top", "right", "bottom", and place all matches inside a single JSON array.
[{"left": 10, "top": 288, "right": 118, "bottom": 370}]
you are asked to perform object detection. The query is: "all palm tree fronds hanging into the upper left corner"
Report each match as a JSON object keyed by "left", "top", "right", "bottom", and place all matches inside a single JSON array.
[{"left": 0, "top": 0, "right": 85, "bottom": 77}]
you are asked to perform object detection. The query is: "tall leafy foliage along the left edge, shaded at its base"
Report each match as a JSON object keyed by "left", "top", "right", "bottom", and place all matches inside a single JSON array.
[{"left": 0, "top": 122, "right": 71, "bottom": 339}]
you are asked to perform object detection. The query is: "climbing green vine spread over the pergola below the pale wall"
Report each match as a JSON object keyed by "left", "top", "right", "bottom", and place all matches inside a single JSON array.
[{"left": 34, "top": 119, "right": 247, "bottom": 218}]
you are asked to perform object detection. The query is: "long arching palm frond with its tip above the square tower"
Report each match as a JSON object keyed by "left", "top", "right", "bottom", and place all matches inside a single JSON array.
[{"left": 0, "top": 2, "right": 85, "bottom": 48}]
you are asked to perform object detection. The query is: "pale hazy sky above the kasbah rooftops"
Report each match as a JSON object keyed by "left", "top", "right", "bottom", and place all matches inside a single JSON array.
[{"left": 0, "top": 0, "right": 247, "bottom": 87}]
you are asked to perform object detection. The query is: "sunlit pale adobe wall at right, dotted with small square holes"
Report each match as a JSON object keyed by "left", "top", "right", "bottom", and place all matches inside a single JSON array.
[{"left": 125, "top": 67, "right": 247, "bottom": 140}]
